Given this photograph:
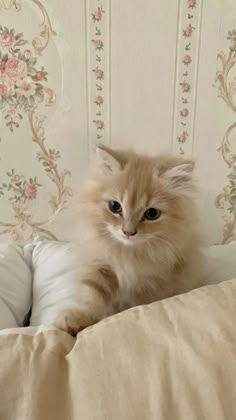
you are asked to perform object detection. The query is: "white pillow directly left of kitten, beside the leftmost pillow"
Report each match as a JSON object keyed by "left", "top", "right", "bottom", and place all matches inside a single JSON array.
[{"left": 26, "top": 239, "right": 78, "bottom": 326}]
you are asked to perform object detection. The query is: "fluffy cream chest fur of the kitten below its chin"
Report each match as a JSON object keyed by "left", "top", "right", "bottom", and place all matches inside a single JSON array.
[{"left": 79, "top": 238, "right": 203, "bottom": 310}]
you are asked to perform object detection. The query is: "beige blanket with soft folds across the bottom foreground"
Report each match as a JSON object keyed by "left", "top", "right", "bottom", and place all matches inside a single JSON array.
[{"left": 0, "top": 280, "right": 236, "bottom": 420}]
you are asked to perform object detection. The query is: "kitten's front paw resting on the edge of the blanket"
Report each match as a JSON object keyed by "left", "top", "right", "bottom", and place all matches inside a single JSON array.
[{"left": 53, "top": 309, "right": 98, "bottom": 337}]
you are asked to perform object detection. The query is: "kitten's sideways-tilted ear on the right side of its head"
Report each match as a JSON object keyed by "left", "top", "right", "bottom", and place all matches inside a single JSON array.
[{"left": 162, "top": 158, "right": 195, "bottom": 192}]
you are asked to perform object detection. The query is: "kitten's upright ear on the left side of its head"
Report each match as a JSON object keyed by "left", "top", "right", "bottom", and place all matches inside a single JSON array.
[{"left": 96, "top": 145, "right": 122, "bottom": 175}]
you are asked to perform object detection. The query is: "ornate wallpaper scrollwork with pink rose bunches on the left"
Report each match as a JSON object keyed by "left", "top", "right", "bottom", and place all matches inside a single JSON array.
[{"left": 0, "top": 0, "right": 72, "bottom": 241}]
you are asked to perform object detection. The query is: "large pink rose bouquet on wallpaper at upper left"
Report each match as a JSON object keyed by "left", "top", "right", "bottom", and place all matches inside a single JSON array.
[{"left": 0, "top": 26, "right": 54, "bottom": 132}]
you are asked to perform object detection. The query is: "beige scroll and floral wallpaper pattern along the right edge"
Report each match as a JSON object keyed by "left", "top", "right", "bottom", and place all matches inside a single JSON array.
[{"left": 215, "top": 29, "right": 236, "bottom": 243}]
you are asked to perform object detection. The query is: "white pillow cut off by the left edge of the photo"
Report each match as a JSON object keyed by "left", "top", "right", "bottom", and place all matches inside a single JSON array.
[{"left": 0, "top": 243, "right": 32, "bottom": 329}]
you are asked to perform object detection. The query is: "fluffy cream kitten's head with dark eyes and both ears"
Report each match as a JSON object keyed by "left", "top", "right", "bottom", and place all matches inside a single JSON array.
[{"left": 81, "top": 146, "right": 195, "bottom": 246}]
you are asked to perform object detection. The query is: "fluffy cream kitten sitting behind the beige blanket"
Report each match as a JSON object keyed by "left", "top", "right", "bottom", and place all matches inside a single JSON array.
[{"left": 56, "top": 146, "right": 205, "bottom": 335}]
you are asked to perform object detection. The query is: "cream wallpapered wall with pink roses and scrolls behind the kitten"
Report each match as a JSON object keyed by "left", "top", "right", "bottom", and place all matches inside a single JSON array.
[{"left": 0, "top": 0, "right": 236, "bottom": 243}]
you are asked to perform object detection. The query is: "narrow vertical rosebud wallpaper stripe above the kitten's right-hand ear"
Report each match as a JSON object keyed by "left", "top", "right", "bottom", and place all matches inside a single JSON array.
[{"left": 173, "top": 0, "right": 202, "bottom": 155}]
